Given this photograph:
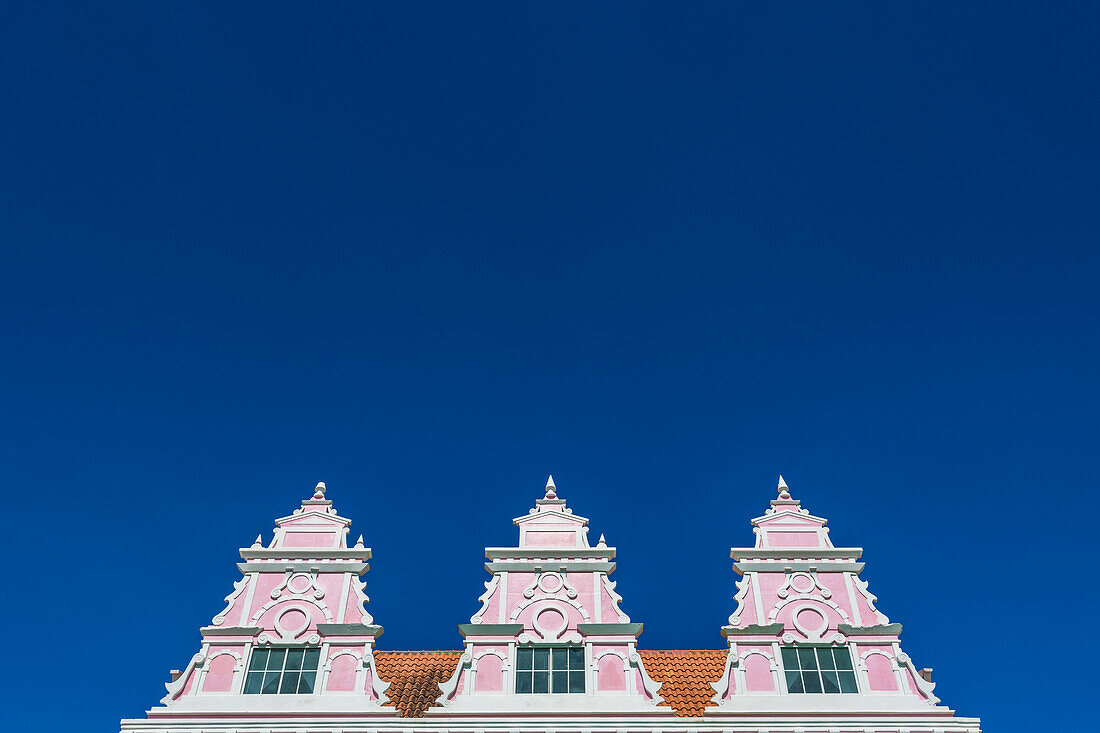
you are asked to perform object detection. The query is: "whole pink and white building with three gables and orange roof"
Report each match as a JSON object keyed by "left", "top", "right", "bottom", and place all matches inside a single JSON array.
[{"left": 121, "top": 477, "right": 980, "bottom": 733}]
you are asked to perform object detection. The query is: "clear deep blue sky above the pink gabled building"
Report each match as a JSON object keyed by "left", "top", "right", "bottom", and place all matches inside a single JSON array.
[{"left": 0, "top": 1, "right": 1100, "bottom": 731}]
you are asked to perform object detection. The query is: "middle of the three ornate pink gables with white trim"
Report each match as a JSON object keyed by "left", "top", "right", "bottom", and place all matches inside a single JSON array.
[{"left": 442, "top": 477, "right": 664, "bottom": 714}]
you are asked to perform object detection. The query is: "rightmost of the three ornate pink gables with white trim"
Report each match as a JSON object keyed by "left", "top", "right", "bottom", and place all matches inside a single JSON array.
[{"left": 714, "top": 477, "right": 952, "bottom": 715}]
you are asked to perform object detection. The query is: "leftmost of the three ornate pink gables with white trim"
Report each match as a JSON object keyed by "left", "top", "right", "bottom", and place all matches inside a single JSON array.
[{"left": 150, "top": 482, "right": 386, "bottom": 719}]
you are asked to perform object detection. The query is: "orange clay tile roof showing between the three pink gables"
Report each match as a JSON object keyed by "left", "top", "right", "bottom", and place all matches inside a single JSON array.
[{"left": 374, "top": 650, "right": 726, "bottom": 718}]
